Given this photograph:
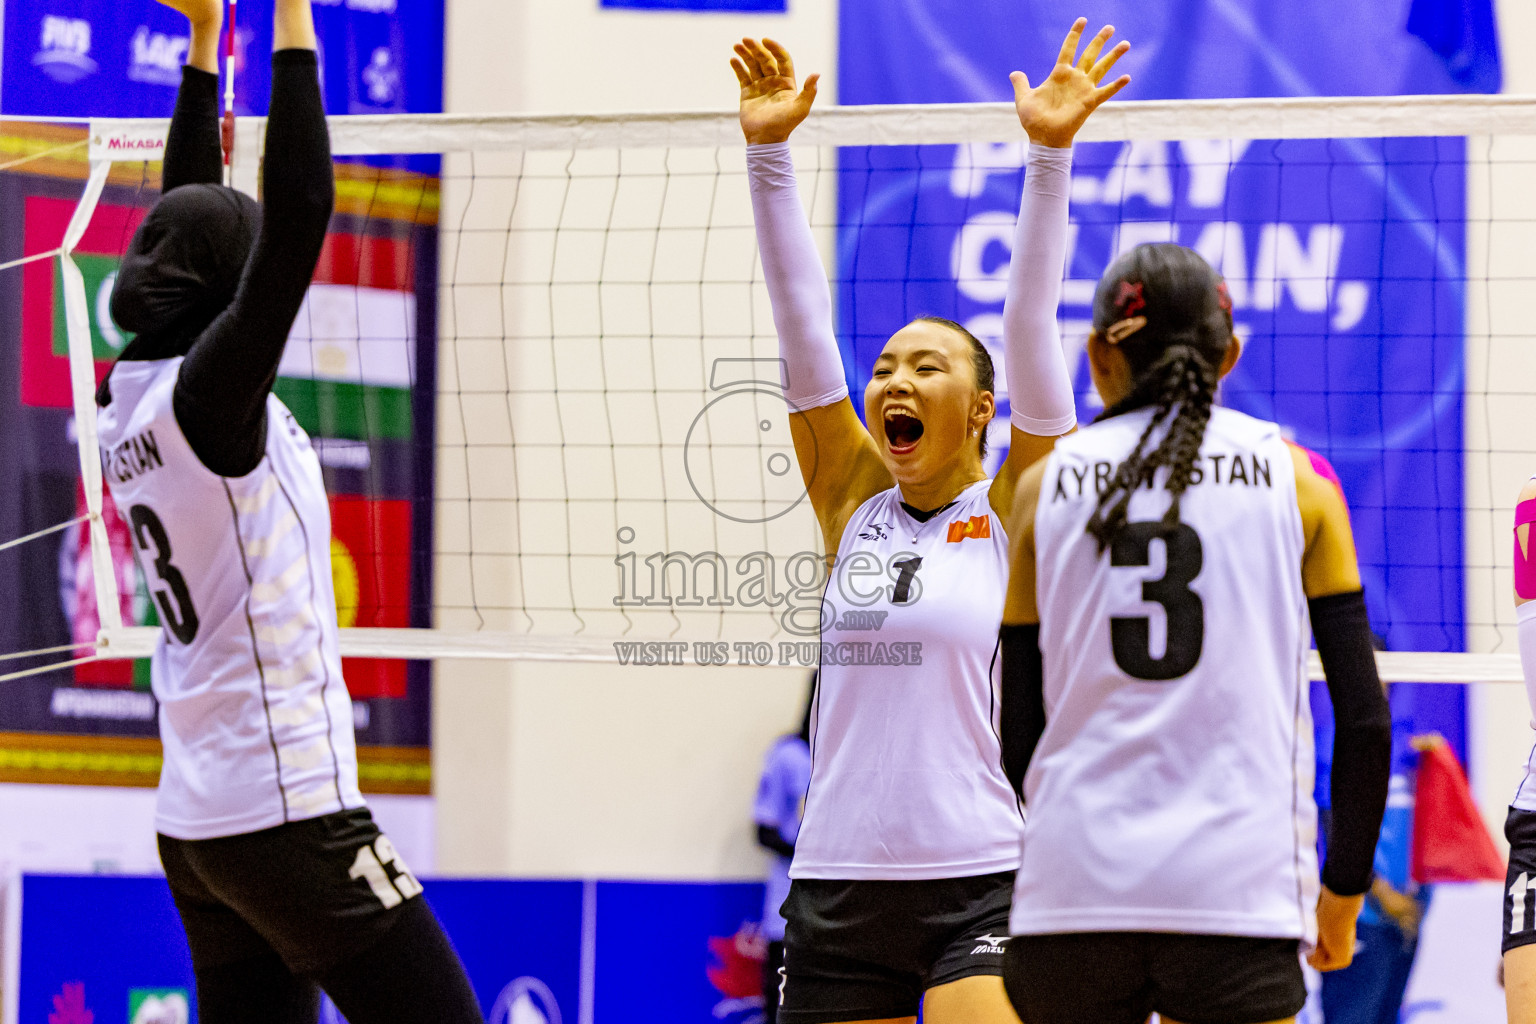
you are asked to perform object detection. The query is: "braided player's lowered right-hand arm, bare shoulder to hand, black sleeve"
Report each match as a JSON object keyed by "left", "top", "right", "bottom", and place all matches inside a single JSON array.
[{"left": 1292, "top": 447, "right": 1392, "bottom": 970}]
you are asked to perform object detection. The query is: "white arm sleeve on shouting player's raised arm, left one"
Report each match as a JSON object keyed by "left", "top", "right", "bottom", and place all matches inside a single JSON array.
[{"left": 746, "top": 143, "right": 848, "bottom": 410}]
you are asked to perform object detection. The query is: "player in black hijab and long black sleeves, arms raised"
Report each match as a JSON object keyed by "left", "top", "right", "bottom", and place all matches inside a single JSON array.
[{"left": 97, "top": 0, "right": 482, "bottom": 1024}]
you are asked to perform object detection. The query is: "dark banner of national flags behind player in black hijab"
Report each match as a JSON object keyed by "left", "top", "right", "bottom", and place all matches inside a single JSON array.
[{"left": 0, "top": 135, "right": 435, "bottom": 764}]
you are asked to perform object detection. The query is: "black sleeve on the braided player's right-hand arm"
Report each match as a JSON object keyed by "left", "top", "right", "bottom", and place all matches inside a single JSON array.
[{"left": 1307, "top": 591, "right": 1392, "bottom": 897}]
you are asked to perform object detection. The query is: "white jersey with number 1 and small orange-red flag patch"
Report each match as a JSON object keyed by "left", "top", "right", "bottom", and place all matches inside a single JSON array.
[{"left": 790, "top": 481, "right": 1021, "bottom": 878}]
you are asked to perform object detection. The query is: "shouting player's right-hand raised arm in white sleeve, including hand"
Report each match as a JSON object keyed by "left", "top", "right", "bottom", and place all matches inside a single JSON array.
[{"left": 992, "top": 18, "right": 1130, "bottom": 516}]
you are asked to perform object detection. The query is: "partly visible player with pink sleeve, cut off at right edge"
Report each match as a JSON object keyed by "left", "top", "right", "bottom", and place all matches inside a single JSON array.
[{"left": 1504, "top": 477, "right": 1536, "bottom": 1024}]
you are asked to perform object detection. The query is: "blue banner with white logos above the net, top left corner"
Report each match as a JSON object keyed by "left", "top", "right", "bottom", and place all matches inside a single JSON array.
[{"left": 0, "top": 0, "right": 448, "bottom": 118}]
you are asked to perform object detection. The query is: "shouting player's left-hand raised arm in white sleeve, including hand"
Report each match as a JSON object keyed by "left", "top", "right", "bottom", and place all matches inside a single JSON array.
[{"left": 731, "top": 38, "right": 891, "bottom": 554}]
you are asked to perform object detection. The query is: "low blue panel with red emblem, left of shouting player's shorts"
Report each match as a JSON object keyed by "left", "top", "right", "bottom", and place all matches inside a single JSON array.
[{"left": 596, "top": 881, "right": 763, "bottom": 1024}]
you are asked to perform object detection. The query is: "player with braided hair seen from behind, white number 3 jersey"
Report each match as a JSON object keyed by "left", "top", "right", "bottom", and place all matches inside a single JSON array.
[{"left": 1003, "top": 244, "right": 1392, "bottom": 1024}]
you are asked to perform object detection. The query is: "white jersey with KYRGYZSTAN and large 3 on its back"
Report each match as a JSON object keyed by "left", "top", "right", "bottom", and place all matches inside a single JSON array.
[{"left": 1011, "top": 408, "right": 1318, "bottom": 943}]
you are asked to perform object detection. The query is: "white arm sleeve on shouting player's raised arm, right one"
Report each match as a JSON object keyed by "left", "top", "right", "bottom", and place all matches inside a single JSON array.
[{"left": 1003, "top": 143, "right": 1077, "bottom": 438}]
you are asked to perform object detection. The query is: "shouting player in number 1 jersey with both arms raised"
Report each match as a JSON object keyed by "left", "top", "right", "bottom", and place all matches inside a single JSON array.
[{"left": 731, "top": 20, "right": 1129, "bottom": 1024}]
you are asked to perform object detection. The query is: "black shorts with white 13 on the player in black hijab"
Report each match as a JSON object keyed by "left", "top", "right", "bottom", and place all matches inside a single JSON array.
[{"left": 160, "top": 808, "right": 421, "bottom": 976}]
